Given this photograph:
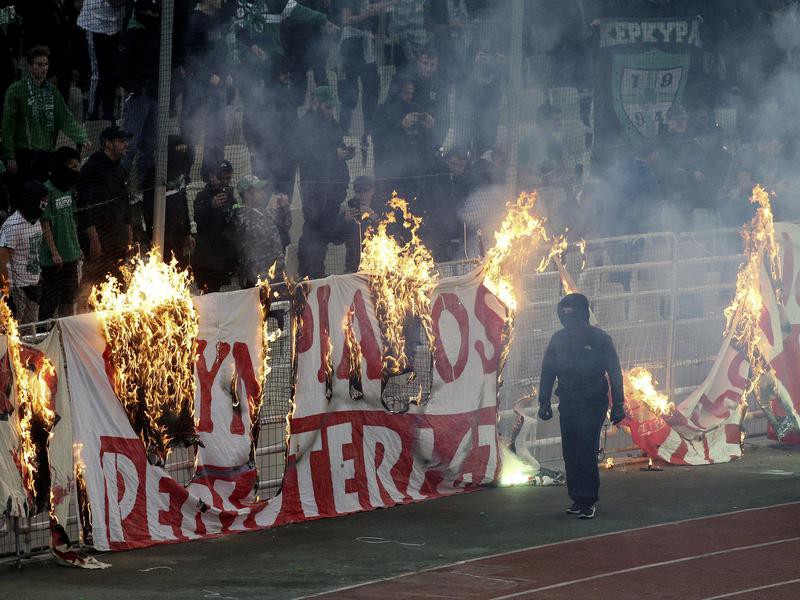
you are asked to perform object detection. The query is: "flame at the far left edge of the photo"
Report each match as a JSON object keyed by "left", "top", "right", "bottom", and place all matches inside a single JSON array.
[{"left": 0, "top": 290, "right": 56, "bottom": 498}]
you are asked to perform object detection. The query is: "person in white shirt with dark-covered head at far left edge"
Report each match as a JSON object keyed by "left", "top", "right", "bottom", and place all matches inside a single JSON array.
[{"left": 0, "top": 180, "right": 48, "bottom": 323}]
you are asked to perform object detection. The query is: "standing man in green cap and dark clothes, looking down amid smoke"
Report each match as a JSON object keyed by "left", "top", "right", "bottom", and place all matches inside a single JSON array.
[{"left": 297, "top": 86, "right": 355, "bottom": 279}]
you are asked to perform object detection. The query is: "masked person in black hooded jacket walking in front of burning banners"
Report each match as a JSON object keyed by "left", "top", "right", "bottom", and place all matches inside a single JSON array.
[{"left": 539, "top": 294, "right": 625, "bottom": 519}]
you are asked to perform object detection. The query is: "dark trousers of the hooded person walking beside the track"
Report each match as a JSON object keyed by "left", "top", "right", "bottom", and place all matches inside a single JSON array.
[{"left": 559, "top": 396, "right": 608, "bottom": 506}]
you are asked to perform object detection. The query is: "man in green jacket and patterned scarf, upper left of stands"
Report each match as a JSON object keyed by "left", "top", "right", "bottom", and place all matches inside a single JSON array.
[{"left": 2, "top": 46, "right": 87, "bottom": 197}]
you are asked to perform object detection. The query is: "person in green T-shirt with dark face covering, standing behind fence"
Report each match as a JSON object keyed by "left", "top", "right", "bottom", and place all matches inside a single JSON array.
[{"left": 39, "top": 146, "right": 81, "bottom": 320}]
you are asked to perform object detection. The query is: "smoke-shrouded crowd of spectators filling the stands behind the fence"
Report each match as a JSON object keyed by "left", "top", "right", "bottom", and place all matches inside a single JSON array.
[{"left": 0, "top": 0, "right": 800, "bottom": 322}]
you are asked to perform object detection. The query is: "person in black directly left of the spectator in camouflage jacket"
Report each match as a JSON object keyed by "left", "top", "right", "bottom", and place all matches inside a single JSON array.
[{"left": 192, "top": 160, "right": 239, "bottom": 292}]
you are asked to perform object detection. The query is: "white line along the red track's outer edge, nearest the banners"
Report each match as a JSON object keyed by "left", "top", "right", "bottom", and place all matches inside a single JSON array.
[{"left": 294, "top": 500, "right": 800, "bottom": 600}]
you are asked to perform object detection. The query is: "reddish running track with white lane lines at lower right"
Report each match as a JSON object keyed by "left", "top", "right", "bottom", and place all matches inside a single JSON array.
[{"left": 300, "top": 502, "right": 800, "bottom": 600}]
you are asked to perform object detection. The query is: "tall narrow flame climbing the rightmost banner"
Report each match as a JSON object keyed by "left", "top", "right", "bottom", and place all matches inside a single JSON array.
[{"left": 725, "top": 185, "right": 781, "bottom": 398}]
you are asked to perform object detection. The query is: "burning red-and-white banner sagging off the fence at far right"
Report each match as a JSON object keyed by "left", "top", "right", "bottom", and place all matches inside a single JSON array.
[{"left": 626, "top": 187, "right": 800, "bottom": 464}]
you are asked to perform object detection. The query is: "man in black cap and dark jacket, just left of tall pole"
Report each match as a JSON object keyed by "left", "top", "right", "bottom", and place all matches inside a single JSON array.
[{"left": 76, "top": 125, "right": 133, "bottom": 297}]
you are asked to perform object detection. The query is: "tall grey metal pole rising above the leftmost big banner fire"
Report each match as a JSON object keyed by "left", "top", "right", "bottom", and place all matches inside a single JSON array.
[{"left": 153, "top": 0, "right": 175, "bottom": 255}]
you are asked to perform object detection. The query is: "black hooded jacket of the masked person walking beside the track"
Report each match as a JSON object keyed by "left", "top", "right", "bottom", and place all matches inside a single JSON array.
[{"left": 539, "top": 294, "right": 624, "bottom": 414}]
